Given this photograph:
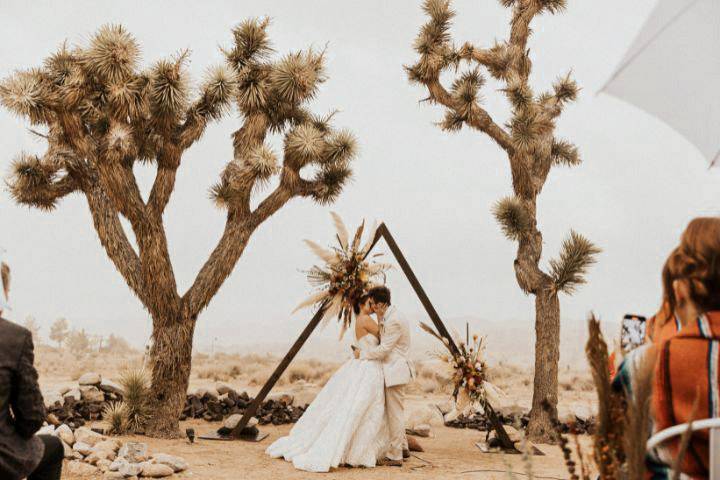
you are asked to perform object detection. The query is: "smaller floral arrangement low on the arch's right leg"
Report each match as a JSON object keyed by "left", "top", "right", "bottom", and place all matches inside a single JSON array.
[{"left": 420, "top": 322, "right": 487, "bottom": 410}]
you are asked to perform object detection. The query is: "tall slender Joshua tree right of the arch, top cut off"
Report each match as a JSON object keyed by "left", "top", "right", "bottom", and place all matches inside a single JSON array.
[{"left": 407, "top": 0, "right": 599, "bottom": 439}]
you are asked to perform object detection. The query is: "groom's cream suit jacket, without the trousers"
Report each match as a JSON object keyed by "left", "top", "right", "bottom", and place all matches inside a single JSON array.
[{"left": 360, "top": 307, "right": 415, "bottom": 387}]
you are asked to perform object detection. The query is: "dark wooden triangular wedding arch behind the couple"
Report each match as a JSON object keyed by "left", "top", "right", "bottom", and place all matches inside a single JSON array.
[{"left": 207, "top": 223, "right": 514, "bottom": 450}]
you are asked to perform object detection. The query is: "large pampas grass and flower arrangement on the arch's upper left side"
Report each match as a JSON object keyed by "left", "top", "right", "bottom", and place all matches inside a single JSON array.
[{"left": 293, "top": 212, "right": 391, "bottom": 337}]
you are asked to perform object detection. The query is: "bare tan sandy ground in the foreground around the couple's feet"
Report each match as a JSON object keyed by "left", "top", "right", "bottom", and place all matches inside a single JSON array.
[{"left": 62, "top": 420, "right": 588, "bottom": 480}]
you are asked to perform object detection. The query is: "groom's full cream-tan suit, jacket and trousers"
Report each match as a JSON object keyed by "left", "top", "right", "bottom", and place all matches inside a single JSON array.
[{"left": 360, "top": 307, "right": 415, "bottom": 460}]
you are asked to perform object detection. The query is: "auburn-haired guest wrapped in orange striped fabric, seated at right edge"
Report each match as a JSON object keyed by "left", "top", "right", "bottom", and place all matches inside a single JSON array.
[{"left": 652, "top": 218, "right": 720, "bottom": 477}]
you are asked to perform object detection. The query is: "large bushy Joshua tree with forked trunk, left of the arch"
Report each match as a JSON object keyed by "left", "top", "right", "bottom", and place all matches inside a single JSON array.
[{"left": 0, "top": 19, "right": 355, "bottom": 436}]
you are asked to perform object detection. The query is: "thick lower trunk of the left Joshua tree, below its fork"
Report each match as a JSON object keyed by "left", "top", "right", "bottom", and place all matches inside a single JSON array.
[{"left": 146, "top": 317, "right": 195, "bottom": 438}]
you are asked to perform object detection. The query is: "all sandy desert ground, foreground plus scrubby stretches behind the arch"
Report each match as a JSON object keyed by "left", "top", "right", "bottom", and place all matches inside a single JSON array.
[{"left": 37, "top": 351, "right": 595, "bottom": 480}]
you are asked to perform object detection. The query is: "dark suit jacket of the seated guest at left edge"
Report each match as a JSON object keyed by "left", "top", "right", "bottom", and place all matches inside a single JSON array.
[{"left": 0, "top": 318, "right": 45, "bottom": 480}]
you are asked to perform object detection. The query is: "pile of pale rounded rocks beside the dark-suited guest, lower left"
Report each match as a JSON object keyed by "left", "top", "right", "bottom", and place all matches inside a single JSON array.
[{"left": 39, "top": 425, "right": 188, "bottom": 479}]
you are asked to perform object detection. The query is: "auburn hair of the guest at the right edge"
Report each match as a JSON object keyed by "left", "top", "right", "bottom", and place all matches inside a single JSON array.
[{"left": 663, "top": 217, "right": 720, "bottom": 312}]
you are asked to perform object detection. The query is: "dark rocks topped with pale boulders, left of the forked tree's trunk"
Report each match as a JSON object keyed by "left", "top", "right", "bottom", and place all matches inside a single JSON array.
[{"left": 44, "top": 373, "right": 122, "bottom": 430}]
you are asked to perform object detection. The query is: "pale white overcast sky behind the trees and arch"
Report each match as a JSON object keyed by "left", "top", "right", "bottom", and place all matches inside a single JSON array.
[{"left": 0, "top": 0, "right": 720, "bottom": 356}]
